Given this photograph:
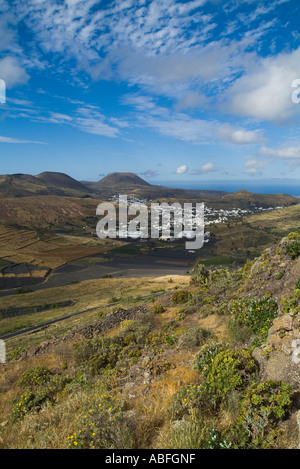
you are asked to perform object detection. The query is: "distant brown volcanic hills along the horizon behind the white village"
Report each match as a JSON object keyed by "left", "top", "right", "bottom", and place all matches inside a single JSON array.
[{"left": 0, "top": 171, "right": 300, "bottom": 209}]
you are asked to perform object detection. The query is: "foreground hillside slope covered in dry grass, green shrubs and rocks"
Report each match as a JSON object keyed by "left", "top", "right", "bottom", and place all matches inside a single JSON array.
[{"left": 0, "top": 233, "right": 300, "bottom": 449}]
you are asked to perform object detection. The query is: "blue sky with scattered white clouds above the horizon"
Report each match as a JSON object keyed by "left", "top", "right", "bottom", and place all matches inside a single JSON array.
[{"left": 0, "top": 0, "right": 300, "bottom": 184}]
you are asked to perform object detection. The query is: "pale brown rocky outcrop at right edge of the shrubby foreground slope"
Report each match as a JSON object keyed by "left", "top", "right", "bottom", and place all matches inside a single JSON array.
[{"left": 247, "top": 235, "right": 300, "bottom": 392}]
